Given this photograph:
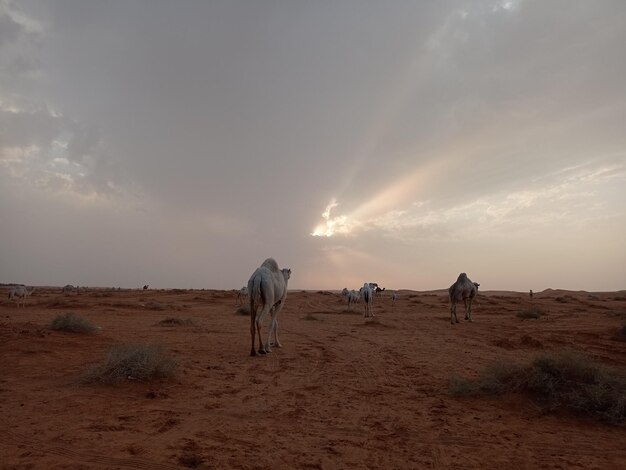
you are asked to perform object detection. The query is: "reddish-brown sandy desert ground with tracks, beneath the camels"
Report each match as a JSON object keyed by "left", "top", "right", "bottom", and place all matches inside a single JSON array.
[{"left": 0, "top": 289, "right": 626, "bottom": 469}]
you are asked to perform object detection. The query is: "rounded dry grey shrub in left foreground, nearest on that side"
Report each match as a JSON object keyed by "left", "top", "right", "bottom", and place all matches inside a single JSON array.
[{"left": 82, "top": 344, "right": 177, "bottom": 384}]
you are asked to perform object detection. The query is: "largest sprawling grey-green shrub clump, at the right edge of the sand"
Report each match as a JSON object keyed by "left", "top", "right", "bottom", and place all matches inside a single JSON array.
[{"left": 448, "top": 350, "right": 626, "bottom": 424}]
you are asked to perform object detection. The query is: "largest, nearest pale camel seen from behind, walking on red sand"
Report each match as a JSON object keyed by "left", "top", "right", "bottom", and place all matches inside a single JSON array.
[{"left": 248, "top": 258, "right": 291, "bottom": 356}]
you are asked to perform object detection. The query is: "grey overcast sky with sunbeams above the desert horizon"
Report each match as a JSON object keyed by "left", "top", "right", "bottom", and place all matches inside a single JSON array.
[{"left": 0, "top": 0, "right": 626, "bottom": 291}]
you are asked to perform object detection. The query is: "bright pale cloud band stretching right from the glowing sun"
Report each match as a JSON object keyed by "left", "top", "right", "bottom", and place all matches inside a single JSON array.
[{"left": 312, "top": 155, "right": 626, "bottom": 242}]
